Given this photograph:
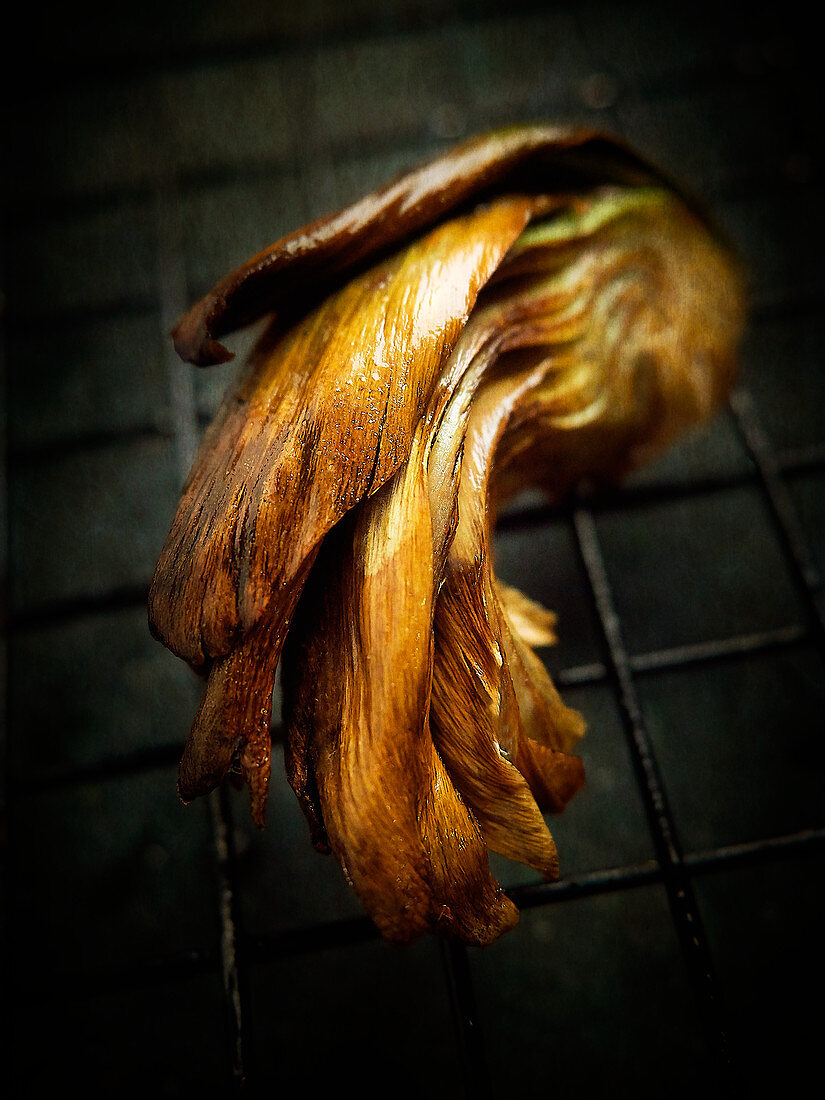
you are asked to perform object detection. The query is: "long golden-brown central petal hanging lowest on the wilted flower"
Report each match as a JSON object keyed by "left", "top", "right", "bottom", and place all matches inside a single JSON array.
[{"left": 285, "top": 431, "right": 517, "bottom": 944}]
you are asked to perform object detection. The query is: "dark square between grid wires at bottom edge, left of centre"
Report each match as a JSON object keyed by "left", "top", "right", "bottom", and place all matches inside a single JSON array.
[{"left": 250, "top": 941, "right": 462, "bottom": 1100}]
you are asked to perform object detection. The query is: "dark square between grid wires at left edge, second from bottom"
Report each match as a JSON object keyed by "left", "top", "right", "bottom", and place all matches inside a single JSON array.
[{"left": 12, "top": 769, "right": 219, "bottom": 989}]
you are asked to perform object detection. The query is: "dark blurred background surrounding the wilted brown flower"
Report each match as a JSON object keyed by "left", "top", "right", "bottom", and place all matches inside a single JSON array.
[{"left": 3, "top": 0, "right": 825, "bottom": 1098}]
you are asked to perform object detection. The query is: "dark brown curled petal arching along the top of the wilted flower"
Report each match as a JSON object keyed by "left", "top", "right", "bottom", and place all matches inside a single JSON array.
[{"left": 174, "top": 125, "right": 690, "bottom": 366}]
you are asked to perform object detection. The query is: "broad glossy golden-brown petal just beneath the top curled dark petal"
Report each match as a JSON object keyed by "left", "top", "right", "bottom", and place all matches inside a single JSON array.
[{"left": 150, "top": 198, "right": 532, "bottom": 668}]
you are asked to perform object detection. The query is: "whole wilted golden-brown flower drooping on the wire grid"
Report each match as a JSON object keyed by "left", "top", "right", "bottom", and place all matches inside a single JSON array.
[{"left": 150, "top": 120, "right": 744, "bottom": 945}]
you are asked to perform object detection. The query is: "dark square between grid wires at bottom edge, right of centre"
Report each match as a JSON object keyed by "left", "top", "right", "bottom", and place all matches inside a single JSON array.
[{"left": 471, "top": 888, "right": 711, "bottom": 1100}]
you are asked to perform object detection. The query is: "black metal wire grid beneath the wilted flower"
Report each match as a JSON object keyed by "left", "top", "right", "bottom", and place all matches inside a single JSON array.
[{"left": 7, "top": 4, "right": 825, "bottom": 1097}]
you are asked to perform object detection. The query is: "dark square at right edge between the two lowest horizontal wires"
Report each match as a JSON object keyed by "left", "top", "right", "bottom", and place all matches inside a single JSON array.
[{"left": 639, "top": 649, "right": 825, "bottom": 850}]
